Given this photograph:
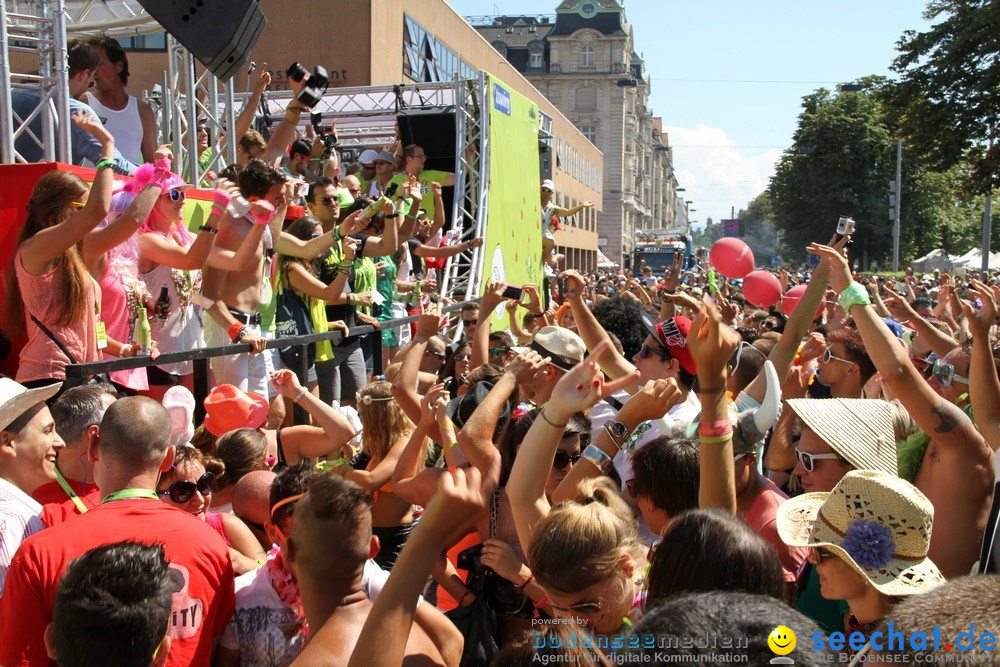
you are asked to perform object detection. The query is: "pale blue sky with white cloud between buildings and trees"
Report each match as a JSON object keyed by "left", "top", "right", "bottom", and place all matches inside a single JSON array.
[{"left": 448, "top": 0, "right": 929, "bottom": 228}]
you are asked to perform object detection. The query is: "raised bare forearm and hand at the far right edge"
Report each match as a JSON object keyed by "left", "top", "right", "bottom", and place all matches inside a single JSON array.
[{"left": 962, "top": 280, "right": 1000, "bottom": 452}]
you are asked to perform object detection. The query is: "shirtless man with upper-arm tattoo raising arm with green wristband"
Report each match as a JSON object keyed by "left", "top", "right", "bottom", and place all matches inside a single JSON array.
[{"left": 808, "top": 244, "right": 993, "bottom": 579}]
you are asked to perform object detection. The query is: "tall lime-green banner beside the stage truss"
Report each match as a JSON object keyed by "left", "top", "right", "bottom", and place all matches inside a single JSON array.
[{"left": 482, "top": 76, "right": 544, "bottom": 320}]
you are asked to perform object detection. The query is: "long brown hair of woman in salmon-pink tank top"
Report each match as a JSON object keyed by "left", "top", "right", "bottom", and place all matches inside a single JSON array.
[{"left": 4, "top": 171, "right": 89, "bottom": 337}]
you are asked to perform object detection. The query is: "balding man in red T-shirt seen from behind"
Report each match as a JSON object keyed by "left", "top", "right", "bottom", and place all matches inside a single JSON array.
[{"left": 0, "top": 396, "right": 235, "bottom": 667}]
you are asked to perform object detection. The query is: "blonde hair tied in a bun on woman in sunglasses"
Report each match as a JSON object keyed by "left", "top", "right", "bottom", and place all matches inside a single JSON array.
[{"left": 528, "top": 477, "right": 639, "bottom": 594}]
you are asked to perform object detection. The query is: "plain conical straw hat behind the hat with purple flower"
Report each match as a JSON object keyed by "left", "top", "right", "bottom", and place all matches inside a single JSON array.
[{"left": 788, "top": 398, "right": 899, "bottom": 475}]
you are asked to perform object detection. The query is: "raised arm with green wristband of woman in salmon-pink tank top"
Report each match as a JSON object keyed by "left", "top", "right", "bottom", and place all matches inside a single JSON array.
[{"left": 18, "top": 112, "right": 115, "bottom": 275}]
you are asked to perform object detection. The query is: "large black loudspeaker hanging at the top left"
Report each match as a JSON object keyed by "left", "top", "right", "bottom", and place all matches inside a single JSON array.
[{"left": 139, "top": 0, "right": 267, "bottom": 81}]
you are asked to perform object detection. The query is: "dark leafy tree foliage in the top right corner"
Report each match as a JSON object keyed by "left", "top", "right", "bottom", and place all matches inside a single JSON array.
[{"left": 887, "top": 0, "right": 1000, "bottom": 194}]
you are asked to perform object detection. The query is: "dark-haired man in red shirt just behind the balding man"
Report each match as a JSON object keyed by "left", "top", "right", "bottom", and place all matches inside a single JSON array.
[{"left": 31, "top": 384, "right": 118, "bottom": 527}]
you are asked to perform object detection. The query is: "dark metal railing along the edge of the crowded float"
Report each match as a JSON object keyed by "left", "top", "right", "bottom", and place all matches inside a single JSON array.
[{"left": 66, "top": 297, "right": 479, "bottom": 424}]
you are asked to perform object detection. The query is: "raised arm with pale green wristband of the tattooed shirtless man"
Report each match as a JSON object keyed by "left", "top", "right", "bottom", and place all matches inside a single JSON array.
[{"left": 808, "top": 243, "right": 985, "bottom": 460}]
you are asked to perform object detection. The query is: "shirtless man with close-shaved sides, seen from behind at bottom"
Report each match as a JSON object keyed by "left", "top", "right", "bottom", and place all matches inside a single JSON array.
[{"left": 285, "top": 475, "right": 461, "bottom": 666}]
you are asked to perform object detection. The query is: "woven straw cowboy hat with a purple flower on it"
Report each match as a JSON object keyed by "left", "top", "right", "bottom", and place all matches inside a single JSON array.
[{"left": 777, "top": 470, "right": 944, "bottom": 595}]
